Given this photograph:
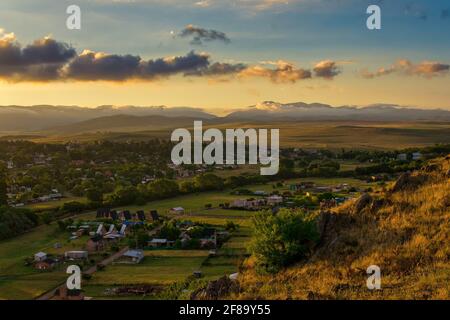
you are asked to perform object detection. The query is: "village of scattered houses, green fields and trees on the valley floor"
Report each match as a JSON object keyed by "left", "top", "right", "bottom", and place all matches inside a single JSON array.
[{"left": 0, "top": 142, "right": 446, "bottom": 299}]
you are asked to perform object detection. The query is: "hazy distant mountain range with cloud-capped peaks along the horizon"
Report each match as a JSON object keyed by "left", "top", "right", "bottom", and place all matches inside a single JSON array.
[{"left": 0, "top": 101, "right": 450, "bottom": 134}]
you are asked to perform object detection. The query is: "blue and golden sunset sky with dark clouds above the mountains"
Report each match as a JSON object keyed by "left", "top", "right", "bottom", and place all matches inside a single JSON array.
[{"left": 0, "top": 0, "right": 450, "bottom": 112}]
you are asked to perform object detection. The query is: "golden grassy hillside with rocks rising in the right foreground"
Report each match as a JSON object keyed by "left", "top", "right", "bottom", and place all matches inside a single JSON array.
[{"left": 237, "top": 155, "right": 450, "bottom": 299}]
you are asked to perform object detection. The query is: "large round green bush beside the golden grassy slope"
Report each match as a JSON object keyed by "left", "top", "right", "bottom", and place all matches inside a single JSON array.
[{"left": 250, "top": 209, "right": 319, "bottom": 273}]
